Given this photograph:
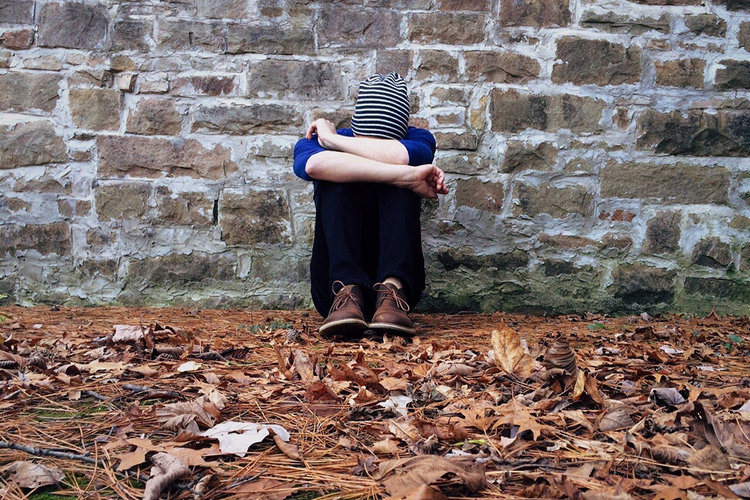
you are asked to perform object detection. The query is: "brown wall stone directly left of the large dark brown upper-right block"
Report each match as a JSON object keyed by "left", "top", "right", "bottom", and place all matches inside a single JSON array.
[{"left": 464, "top": 51, "right": 541, "bottom": 83}]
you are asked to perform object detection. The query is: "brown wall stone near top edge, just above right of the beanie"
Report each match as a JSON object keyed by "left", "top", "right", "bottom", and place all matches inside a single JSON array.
[{"left": 409, "top": 12, "right": 485, "bottom": 45}]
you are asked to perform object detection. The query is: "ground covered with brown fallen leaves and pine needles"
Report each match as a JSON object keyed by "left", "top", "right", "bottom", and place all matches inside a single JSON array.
[{"left": 0, "top": 306, "right": 750, "bottom": 500}]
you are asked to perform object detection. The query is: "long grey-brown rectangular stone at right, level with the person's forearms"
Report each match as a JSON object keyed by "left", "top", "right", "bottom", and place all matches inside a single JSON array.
[{"left": 599, "top": 160, "right": 731, "bottom": 204}]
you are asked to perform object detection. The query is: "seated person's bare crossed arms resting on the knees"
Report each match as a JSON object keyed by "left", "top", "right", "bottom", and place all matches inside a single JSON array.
[{"left": 295, "top": 118, "right": 448, "bottom": 198}]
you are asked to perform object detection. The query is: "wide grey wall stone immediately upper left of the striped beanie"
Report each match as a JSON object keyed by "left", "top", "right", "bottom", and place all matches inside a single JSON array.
[{"left": 247, "top": 60, "right": 344, "bottom": 100}]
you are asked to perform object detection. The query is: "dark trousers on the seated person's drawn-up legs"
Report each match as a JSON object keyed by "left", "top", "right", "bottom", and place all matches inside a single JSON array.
[{"left": 310, "top": 181, "right": 425, "bottom": 317}]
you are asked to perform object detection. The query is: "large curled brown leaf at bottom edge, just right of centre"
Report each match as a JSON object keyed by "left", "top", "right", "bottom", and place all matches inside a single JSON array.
[{"left": 375, "top": 455, "right": 487, "bottom": 497}]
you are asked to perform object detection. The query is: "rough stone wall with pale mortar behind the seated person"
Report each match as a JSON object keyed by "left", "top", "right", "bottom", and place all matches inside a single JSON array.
[{"left": 0, "top": 0, "right": 750, "bottom": 314}]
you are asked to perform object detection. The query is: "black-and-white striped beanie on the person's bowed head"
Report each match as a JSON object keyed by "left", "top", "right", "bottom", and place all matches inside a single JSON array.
[{"left": 352, "top": 72, "right": 411, "bottom": 139}]
